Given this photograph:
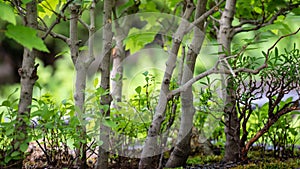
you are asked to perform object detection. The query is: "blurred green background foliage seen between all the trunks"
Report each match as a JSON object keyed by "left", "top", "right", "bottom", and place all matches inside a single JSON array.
[{"left": 0, "top": 0, "right": 300, "bottom": 167}]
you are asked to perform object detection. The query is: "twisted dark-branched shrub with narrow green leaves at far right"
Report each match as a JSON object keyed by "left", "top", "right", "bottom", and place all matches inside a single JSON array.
[{"left": 235, "top": 45, "right": 300, "bottom": 157}]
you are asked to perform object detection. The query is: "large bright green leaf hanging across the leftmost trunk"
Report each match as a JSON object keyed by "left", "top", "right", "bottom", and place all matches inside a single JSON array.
[{"left": 5, "top": 25, "right": 49, "bottom": 53}]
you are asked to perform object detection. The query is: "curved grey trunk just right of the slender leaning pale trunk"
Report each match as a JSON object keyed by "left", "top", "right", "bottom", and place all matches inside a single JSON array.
[{"left": 166, "top": 0, "right": 207, "bottom": 167}]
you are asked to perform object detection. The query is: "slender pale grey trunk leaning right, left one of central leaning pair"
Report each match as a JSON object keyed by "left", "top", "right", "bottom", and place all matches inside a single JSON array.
[{"left": 139, "top": 0, "right": 195, "bottom": 169}]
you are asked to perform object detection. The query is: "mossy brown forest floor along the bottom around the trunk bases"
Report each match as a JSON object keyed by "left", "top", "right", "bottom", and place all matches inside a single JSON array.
[{"left": 18, "top": 142, "right": 300, "bottom": 169}]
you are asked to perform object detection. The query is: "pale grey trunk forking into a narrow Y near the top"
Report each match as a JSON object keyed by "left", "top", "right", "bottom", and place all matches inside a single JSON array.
[{"left": 69, "top": 1, "right": 96, "bottom": 168}]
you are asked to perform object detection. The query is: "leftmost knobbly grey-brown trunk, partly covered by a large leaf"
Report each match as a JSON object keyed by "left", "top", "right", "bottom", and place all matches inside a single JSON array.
[{"left": 13, "top": 0, "right": 38, "bottom": 168}]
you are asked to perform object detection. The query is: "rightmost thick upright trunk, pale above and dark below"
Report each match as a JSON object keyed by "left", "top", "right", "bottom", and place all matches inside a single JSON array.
[{"left": 218, "top": 0, "right": 240, "bottom": 161}]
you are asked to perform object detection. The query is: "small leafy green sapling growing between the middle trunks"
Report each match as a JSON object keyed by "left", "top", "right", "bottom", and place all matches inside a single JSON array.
[{"left": 111, "top": 71, "right": 158, "bottom": 138}]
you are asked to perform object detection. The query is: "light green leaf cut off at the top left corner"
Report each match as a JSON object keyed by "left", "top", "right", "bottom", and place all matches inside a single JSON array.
[{"left": 0, "top": 1, "right": 16, "bottom": 25}]
